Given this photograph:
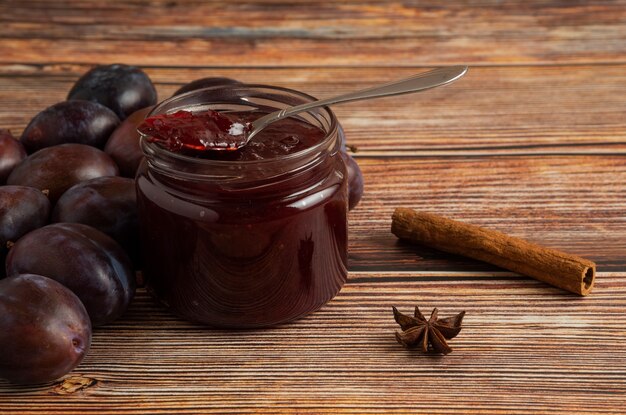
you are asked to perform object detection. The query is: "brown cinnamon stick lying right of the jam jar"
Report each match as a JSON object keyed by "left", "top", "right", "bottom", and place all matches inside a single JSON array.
[{"left": 391, "top": 208, "right": 596, "bottom": 295}]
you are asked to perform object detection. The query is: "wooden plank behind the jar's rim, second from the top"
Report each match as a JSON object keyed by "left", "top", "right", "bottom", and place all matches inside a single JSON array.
[{"left": 0, "top": 64, "right": 626, "bottom": 156}]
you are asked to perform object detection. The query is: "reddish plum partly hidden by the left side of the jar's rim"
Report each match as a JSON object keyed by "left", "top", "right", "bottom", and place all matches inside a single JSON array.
[{"left": 104, "top": 107, "right": 154, "bottom": 178}]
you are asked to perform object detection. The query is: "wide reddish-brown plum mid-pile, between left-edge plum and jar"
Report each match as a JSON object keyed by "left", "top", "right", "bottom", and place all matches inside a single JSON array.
[{"left": 7, "top": 144, "right": 119, "bottom": 204}]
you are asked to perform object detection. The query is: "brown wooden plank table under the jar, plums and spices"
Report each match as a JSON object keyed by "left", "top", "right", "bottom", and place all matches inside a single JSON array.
[{"left": 0, "top": 0, "right": 626, "bottom": 415}]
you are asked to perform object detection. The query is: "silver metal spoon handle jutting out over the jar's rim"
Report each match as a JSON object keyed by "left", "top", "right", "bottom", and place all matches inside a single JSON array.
[{"left": 248, "top": 66, "right": 467, "bottom": 140}]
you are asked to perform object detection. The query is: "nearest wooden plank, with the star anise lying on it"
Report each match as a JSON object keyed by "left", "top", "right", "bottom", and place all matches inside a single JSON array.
[{"left": 0, "top": 273, "right": 626, "bottom": 415}]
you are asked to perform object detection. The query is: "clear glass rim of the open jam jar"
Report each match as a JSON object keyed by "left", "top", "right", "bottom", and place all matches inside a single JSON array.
[{"left": 139, "top": 83, "right": 339, "bottom": 167}]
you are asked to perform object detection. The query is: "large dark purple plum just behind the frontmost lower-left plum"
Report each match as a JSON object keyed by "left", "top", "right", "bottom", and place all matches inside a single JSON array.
[{"left": 6, "top": 223, "right": 135, "bottom": 327}]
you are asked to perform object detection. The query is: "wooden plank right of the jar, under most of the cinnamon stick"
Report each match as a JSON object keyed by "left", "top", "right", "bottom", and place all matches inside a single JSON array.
[{"left": 349, "top": 155, "right": 626, "bottom": 271}]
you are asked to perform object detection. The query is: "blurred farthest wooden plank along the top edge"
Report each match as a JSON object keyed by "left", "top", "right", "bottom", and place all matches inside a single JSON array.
[{"left": 0, "top": 0, "right": 626, "bottom": 66}]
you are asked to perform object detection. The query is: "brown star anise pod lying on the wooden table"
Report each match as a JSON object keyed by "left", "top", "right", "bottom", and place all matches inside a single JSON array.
[{"left": 393, "top": 306, "right": 465, "bottom": 354}]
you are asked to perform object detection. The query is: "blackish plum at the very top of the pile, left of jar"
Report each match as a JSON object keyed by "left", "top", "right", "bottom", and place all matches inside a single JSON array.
[{"left": 67, "top": 64, "right": 157, "bottom": 120}]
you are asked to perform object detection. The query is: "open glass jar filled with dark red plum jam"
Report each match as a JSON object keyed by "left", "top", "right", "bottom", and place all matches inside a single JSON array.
[{"left": 136, "top": 85, "right": 348, "bottom": 328}]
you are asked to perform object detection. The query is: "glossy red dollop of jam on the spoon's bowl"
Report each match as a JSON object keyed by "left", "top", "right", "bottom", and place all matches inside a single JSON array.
[{"left": 138, "top": 110, "right": 250, "bottom": 152}]
